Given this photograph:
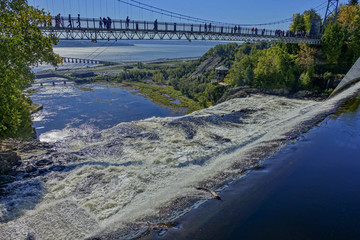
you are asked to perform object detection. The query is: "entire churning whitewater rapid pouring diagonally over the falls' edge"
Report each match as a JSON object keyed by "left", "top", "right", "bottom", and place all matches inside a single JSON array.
[{"left": 0, "top": 83, "right": 360, "bottom": 239}]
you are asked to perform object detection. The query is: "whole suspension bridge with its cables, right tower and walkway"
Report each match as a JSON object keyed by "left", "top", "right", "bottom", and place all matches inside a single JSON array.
[{"left": 33, "top": 0, "right": 339, "bottom": 45}]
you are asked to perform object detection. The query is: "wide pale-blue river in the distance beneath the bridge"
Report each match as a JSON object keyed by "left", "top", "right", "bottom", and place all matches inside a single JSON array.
[{"left": 33, "top": 40, "right": 220, "bottom": 72}]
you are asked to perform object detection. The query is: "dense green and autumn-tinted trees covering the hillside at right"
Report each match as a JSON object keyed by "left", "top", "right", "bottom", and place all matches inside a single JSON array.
[{"left": 89, "top": 1, "right": 360, "bottom": 107}]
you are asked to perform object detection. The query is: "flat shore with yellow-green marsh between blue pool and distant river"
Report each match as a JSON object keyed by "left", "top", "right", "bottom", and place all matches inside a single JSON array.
[{"left": 36, "top": 58, "right": 203, "bottom": 113}]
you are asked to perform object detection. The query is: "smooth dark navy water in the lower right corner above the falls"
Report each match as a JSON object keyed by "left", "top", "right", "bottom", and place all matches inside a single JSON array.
[{"left": 162, "top": 94, "right": 360, "bottom": 239}]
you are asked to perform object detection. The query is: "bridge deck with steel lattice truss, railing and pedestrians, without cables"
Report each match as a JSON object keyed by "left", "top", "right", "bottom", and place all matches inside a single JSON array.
[{"left": 40, "top": 17, "right": 321, "bottom": 45}]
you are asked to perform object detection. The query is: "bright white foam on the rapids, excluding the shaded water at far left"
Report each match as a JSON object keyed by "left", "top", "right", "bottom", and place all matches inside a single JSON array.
[{"left": 0, "top": 83, "right": 360, "bottom": 239}]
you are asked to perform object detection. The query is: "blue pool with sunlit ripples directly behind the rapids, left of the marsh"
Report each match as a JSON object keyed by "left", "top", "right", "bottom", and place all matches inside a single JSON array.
[{"left": 31, "top": 82, "right": 180, "bottom": 136}]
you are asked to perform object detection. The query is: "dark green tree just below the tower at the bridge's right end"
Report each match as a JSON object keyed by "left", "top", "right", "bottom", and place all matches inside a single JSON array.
[{"left": 321, "top": 22, "right": 347, "bottom": 63}]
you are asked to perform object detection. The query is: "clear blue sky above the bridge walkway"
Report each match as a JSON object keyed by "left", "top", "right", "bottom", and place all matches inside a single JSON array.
[{"left": 28, "top": 0, "right": 348, "bottom": 28}]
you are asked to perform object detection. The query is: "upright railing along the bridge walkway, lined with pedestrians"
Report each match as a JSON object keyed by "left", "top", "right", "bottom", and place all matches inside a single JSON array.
[{"left": 45, "top": 17, "right": 320, "bottom": 39}]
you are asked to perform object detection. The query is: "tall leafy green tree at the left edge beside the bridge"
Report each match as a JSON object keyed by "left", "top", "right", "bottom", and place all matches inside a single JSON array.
[{"left": 0, "top": 0, "right": 61, "bottom": 138}]
